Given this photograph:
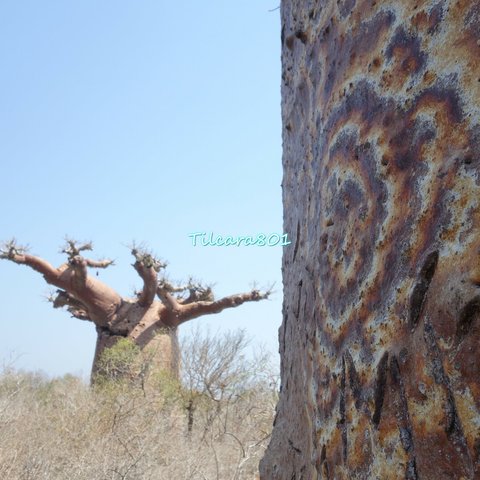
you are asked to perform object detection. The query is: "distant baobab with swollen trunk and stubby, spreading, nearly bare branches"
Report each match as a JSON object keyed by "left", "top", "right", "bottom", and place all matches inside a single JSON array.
[{"left": 0, "top": 240, "right": 270, "bottom": 380}]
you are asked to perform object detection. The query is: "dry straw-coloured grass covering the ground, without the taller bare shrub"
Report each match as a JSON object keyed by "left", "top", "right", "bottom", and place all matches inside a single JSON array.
[{"left": 0, "top": 346, "right": 276, "bottom": 480}]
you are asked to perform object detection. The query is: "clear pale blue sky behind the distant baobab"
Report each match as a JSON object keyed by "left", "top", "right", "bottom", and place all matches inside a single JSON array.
[{"left": 0, "top": 0, "right": 284, "bottom": 376}]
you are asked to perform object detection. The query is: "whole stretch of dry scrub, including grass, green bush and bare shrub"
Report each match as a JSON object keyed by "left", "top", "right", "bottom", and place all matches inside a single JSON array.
[{"left": 0, "top": 331, "right": 278, "bottom": 480}]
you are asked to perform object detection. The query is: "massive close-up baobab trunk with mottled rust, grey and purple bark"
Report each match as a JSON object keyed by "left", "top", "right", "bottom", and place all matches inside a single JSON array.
[{"left": 261, "top": 0, "right": 480, "bottom": 480}]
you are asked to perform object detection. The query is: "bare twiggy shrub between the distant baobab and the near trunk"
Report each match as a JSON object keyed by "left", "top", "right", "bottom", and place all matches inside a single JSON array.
[{"left": 181, "top": 328, "right": 279, "bottom": 479}]
